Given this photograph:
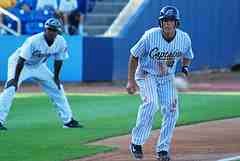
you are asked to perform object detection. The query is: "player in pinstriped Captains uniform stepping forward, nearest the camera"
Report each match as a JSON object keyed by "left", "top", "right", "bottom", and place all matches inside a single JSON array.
[{"left": 126, "top": 6, "right": 193, "bottom": 161}]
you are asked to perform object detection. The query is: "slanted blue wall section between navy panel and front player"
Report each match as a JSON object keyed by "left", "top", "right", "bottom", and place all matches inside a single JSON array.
[{"left": 113, "top": 0, "right": 159, "bottom": 80}]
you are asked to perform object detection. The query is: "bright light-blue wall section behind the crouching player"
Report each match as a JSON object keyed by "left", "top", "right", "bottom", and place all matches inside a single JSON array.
[{"left": 0, "top": 36, "right": 83, "bottom": 82}]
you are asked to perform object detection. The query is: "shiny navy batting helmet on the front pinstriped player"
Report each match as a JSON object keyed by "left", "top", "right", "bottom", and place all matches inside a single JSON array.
[{"left": 158, "top": 6, "right": 180, "bottom": 26}]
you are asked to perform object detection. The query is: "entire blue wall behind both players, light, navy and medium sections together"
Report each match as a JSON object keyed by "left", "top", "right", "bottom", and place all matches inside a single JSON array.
[{"left": 0, "top": 0, "right": 240, "bottom": 82}]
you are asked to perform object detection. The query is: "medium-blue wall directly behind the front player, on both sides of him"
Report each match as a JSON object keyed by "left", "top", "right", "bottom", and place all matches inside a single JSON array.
[{"left": 113, "top": 0, "right": 240, "bottom": 80}]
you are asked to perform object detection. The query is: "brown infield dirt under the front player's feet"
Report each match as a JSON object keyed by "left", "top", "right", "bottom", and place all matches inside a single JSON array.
[{"left": 74, "top": 118, "right": 240, "bottom": 161}]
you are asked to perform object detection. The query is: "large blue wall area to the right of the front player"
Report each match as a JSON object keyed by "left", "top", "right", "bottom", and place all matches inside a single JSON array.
[{"left": 160, "top": 0, "right": 240, "bottom": 69}]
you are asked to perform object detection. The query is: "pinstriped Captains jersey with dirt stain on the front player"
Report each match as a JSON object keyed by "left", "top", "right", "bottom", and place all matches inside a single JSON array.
[{"left": 130, "top": 27, "right": 194, "bottom": 78}]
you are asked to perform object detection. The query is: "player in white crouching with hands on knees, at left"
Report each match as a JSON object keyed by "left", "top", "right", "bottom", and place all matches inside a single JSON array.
[{"left": 0, "top": 18, "right": 82, "bottom": 130}]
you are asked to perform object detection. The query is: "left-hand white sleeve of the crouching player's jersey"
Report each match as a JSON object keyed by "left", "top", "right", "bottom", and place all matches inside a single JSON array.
[{"left": 19, "top": 39, "right": 33, "bottom": 60}]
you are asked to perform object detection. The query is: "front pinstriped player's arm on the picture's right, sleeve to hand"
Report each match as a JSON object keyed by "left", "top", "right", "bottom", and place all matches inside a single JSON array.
[{"left": 182, "top": 35, "right": 194, "bottom": 76}]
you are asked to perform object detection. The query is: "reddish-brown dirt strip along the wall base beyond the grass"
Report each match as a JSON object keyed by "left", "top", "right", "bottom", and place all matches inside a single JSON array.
[{"left": 0, "top": 72, "right": 240, "bottom": 93}]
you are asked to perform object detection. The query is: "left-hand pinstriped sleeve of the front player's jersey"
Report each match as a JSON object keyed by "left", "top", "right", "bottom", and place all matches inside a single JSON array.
[{"left": 130, "top": 32, "right": 147, "bottom": 57}]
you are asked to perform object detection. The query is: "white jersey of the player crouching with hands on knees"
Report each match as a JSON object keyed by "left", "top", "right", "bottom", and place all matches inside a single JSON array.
[{"left": 11, "top": 32, "right": 68, "bottom": 67}]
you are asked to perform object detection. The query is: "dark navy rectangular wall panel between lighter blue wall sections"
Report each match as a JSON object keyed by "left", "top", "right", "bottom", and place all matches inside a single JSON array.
[{"left": 82, "top": 37, "right": 113, "bottom": 82}]
